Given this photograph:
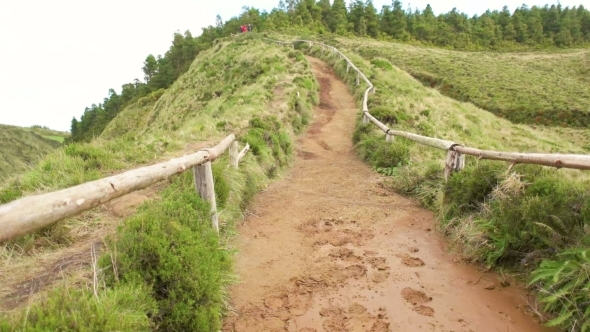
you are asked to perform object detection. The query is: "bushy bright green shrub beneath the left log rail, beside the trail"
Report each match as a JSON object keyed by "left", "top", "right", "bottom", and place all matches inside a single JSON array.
[{"left": 102, "top": 173, "right": 231, "bottom": 331}]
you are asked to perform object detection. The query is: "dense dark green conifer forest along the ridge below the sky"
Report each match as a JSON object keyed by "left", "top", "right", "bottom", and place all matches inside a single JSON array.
[{"left": 68, "top": 0, "right": 590, "bottom": 142}]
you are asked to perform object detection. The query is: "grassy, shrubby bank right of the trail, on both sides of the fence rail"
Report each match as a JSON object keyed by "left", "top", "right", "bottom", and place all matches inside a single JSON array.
[{"left": 298, "top": 38, "right": 590, "bottom": 331}]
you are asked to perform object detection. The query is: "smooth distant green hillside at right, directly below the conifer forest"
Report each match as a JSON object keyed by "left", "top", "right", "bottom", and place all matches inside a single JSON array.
[{"left": 337, "top": 38, "right": 590, "bottom": 128}]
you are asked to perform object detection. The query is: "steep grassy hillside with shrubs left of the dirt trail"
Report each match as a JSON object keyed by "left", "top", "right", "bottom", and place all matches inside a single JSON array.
[{"left": 0, "top": 35, "right": 318, "bottom": 331}]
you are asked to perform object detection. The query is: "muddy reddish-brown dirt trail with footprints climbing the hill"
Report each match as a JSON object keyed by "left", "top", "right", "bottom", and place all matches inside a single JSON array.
[{"left": 223, "top": 58, "right": 556, "bottom": 332}]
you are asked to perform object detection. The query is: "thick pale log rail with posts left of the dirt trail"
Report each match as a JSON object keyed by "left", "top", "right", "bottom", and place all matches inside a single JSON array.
[{"left": 0, "top": 134, "right": 250, "bottom": 243}]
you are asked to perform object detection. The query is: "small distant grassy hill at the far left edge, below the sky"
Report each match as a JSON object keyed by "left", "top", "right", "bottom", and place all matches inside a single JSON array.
[{"left": 0, "top": 124, "right": 67, "bottom": 183}]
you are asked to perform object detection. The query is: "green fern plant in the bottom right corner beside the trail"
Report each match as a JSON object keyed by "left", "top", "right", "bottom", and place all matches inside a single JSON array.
[{"left": 531, "top": 248, "right": 590, "bottom": 332}]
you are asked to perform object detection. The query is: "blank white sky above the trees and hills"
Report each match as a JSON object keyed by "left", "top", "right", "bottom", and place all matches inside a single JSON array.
[{"left": 0, "top": 0, "right": 590, "bottom": 130}]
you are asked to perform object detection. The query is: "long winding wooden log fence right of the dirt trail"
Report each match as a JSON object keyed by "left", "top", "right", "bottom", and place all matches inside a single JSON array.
[{"left": 265, "top": 38, "right": 590, "bottom": 174}]
